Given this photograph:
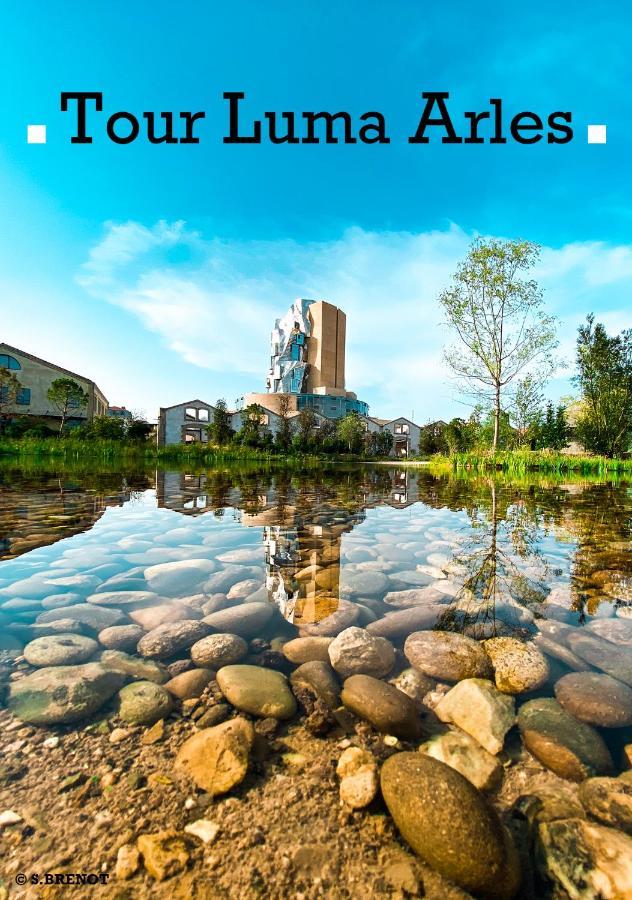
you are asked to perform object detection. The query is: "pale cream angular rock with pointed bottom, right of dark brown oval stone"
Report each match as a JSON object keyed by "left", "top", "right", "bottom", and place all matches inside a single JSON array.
[{"left": 434, "top": 678, "right": 516, "bottom": 755}]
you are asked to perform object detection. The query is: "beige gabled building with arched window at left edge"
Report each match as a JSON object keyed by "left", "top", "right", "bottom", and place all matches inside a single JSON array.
[{"left": 0, "top": 343, "right": 108, "bottom": 425}]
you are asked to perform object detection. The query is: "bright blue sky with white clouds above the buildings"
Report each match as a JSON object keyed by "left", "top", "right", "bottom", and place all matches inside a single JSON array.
[{"left": 0, "top": 0, "right": 632, "bottom": 422}]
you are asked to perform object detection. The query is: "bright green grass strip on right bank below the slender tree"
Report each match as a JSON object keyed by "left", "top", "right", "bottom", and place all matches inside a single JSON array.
[{"left": 449, "top": 450, "right": 632, "bottom": 475}]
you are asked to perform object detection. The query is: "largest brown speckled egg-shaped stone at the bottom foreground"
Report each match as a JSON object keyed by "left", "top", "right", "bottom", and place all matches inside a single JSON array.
[{"left": 380, "top": 753, "right": 520, "bottom": 898}]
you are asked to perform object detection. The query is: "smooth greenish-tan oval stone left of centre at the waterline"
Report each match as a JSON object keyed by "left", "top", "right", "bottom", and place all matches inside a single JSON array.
[{"left": 217, "top": 665, "right": 296, "bottom": 719}]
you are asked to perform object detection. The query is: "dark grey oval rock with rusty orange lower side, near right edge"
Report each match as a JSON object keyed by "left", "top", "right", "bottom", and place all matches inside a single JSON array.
[{"left": 518, "top": 698, "right": 613, "bottom": 781}]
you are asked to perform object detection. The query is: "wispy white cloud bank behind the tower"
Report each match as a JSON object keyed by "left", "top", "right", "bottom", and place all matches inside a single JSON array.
[{"left": 78, "top": 222, "right": 632, "bottom": 420}]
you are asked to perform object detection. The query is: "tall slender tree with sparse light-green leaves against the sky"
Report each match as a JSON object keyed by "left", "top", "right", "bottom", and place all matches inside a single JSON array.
[{"left": 439, "top": 239, "right": 557, "bottom": 451}]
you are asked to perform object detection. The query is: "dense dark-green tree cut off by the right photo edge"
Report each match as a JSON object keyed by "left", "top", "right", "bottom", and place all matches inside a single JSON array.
[{"left": 575, "top": 314, "right": 632, "bottom": 457}]
